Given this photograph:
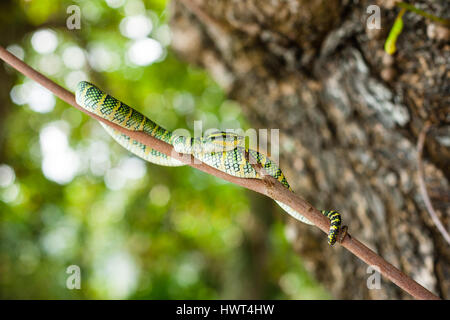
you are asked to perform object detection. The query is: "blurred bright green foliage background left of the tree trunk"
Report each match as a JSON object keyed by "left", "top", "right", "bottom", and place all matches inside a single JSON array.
[{"left": 0, "top": 0, "right": 329, "bottom": 299}]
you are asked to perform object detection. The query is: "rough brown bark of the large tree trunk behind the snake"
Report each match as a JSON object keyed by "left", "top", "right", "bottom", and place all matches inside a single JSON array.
[{"left": 171, "top": 0, "right": 450, "bottom": 299}]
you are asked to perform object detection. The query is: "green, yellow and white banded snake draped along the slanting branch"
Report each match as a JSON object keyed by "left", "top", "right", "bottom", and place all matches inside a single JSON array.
[{"left": 76, "top": 81, "right": 341, "bottom": 245}]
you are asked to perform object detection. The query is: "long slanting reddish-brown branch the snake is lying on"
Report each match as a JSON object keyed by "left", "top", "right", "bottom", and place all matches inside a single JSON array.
[{"left": 0, "top": 47, "right": 439, "bottom": 300}]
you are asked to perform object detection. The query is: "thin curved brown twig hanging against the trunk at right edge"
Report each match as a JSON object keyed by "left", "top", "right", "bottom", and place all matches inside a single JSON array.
[{"left": 417, "top": 121, "right": 450, "bottom": 244}]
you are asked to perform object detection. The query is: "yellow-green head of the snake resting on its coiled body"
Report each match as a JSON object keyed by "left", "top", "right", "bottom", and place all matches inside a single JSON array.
[{"left": 201, "top": 131, "right": 245, "bottom": 153}]
